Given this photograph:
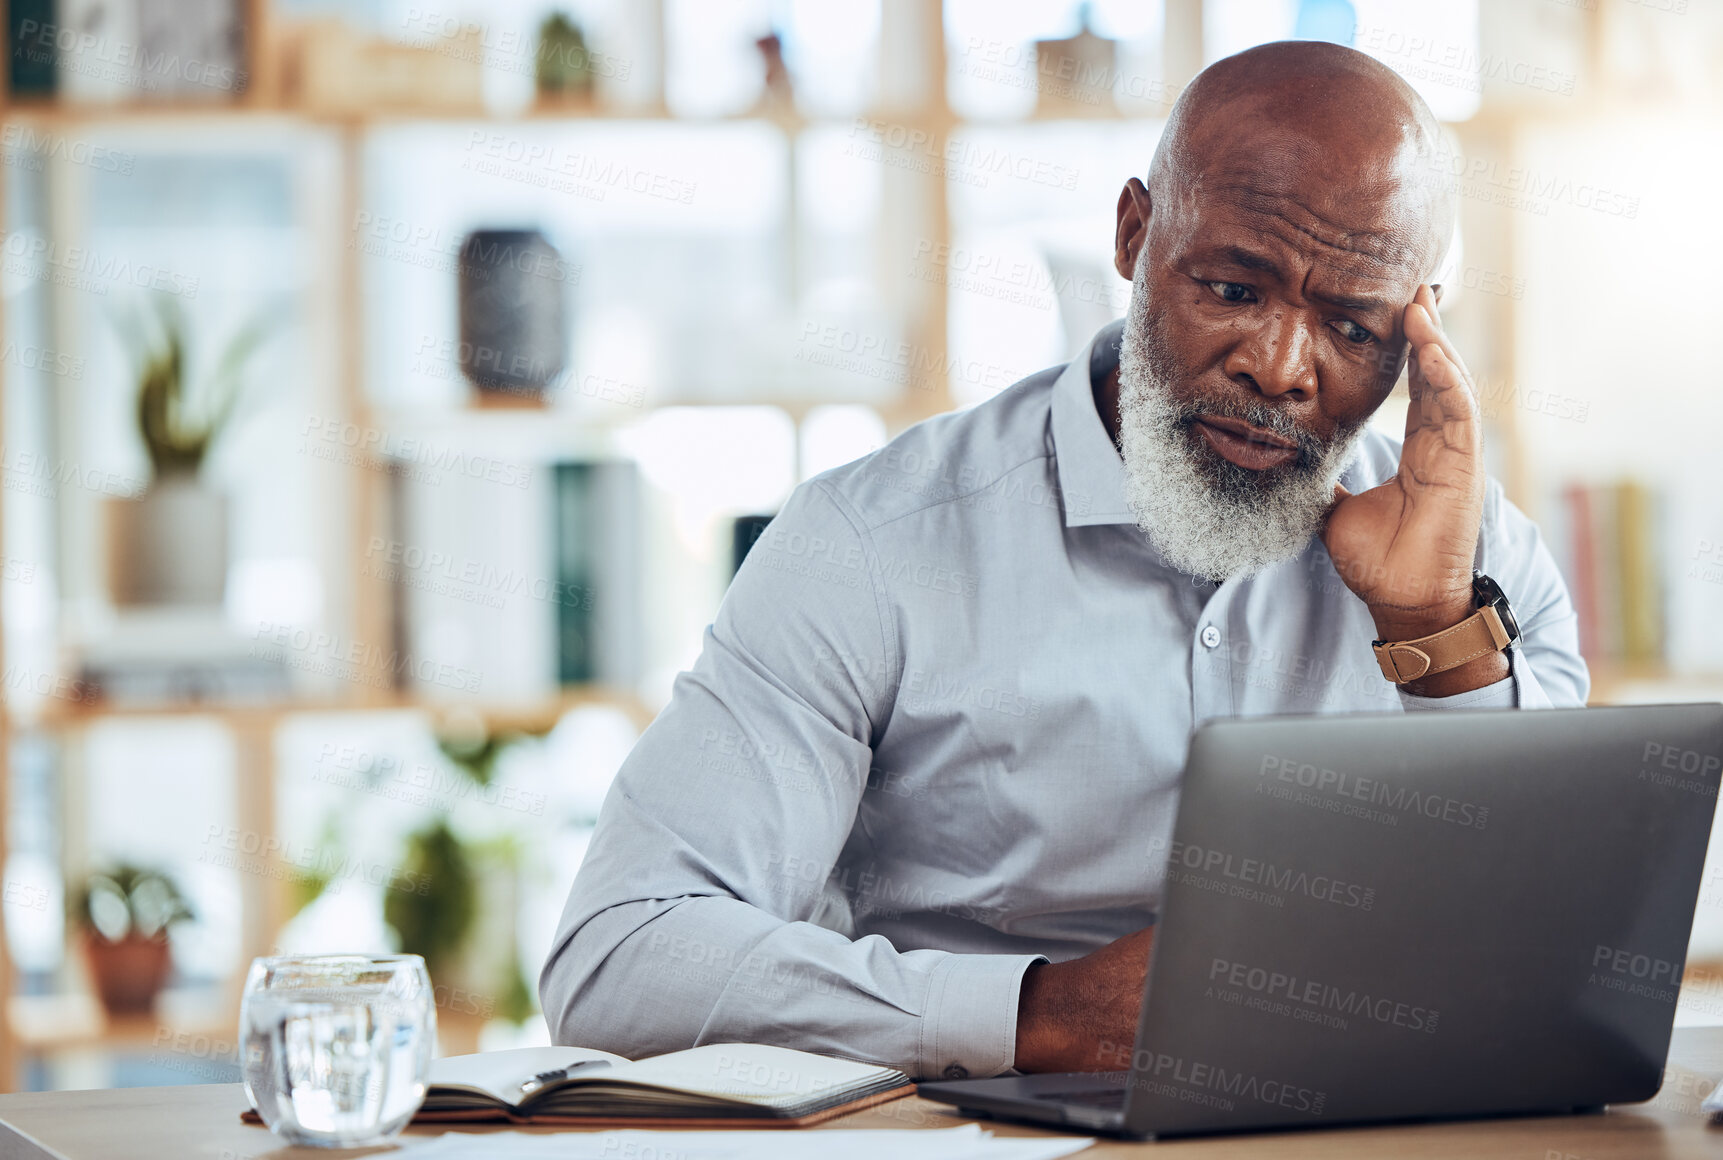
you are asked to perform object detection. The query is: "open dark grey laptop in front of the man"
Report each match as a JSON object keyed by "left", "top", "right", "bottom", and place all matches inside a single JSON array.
[{"left": 920, "top": 703, "right": 1723, "bottom": 1138}]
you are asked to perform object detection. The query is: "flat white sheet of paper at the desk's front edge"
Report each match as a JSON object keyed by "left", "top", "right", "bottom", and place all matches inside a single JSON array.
[{"left": 384, "top": 1124, "right": 1094, "bottom": 1160}]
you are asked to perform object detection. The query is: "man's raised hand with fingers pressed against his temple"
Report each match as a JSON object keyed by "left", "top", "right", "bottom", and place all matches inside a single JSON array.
[{"left": 1323, "top": 286, "right": 1508, "bottom": 696}]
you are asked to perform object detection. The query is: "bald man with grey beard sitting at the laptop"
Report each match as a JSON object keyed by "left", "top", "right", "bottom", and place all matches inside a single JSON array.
[{"left": 541, "top": 43, "right": 1587, "bottom": 1079}]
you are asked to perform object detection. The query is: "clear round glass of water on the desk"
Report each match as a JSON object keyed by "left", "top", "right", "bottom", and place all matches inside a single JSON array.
[{"left": 239, "top": 955, "right": 436, "bottom": 1148}]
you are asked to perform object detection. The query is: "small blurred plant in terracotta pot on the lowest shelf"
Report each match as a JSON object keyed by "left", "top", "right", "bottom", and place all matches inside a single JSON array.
[{"left": 74, "top": 864, "right": 195, "bottom": 1015}]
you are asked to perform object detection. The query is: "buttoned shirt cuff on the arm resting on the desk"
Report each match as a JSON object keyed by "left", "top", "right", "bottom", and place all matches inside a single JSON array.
[{"left": 918, "top": 955, "right": 1048, "bottom": 1079}]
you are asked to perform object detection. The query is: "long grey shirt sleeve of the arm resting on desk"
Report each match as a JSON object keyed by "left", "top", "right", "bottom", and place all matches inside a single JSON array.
[{"left": 539, "top": 479, "right": 1039, "bottom": 1076}]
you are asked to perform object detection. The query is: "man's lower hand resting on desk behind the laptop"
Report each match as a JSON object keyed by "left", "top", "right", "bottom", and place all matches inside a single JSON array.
[{"left": 1017, "top": 927, "right": 1154, "bottom": 1072}]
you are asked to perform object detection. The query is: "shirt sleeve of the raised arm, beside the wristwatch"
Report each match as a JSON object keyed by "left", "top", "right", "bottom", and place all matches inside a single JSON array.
[{"left": 1401, "top": 481, "right": 1590, "bottom": 710}]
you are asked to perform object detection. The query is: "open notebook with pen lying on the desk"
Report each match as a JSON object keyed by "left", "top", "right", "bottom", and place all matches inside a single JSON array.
[{"left": 242, "top": 1043, "right": 915, "bottom": 1127}]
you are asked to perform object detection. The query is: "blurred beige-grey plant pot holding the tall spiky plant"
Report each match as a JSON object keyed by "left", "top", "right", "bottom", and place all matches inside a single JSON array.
[{"left": 107, "top": 474, "right": 227, "bottom": 607}]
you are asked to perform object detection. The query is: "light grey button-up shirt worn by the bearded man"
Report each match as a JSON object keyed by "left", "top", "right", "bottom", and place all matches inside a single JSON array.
[{"left": 541, "top": 324, "right": 1589, "bottom": 1077}]
